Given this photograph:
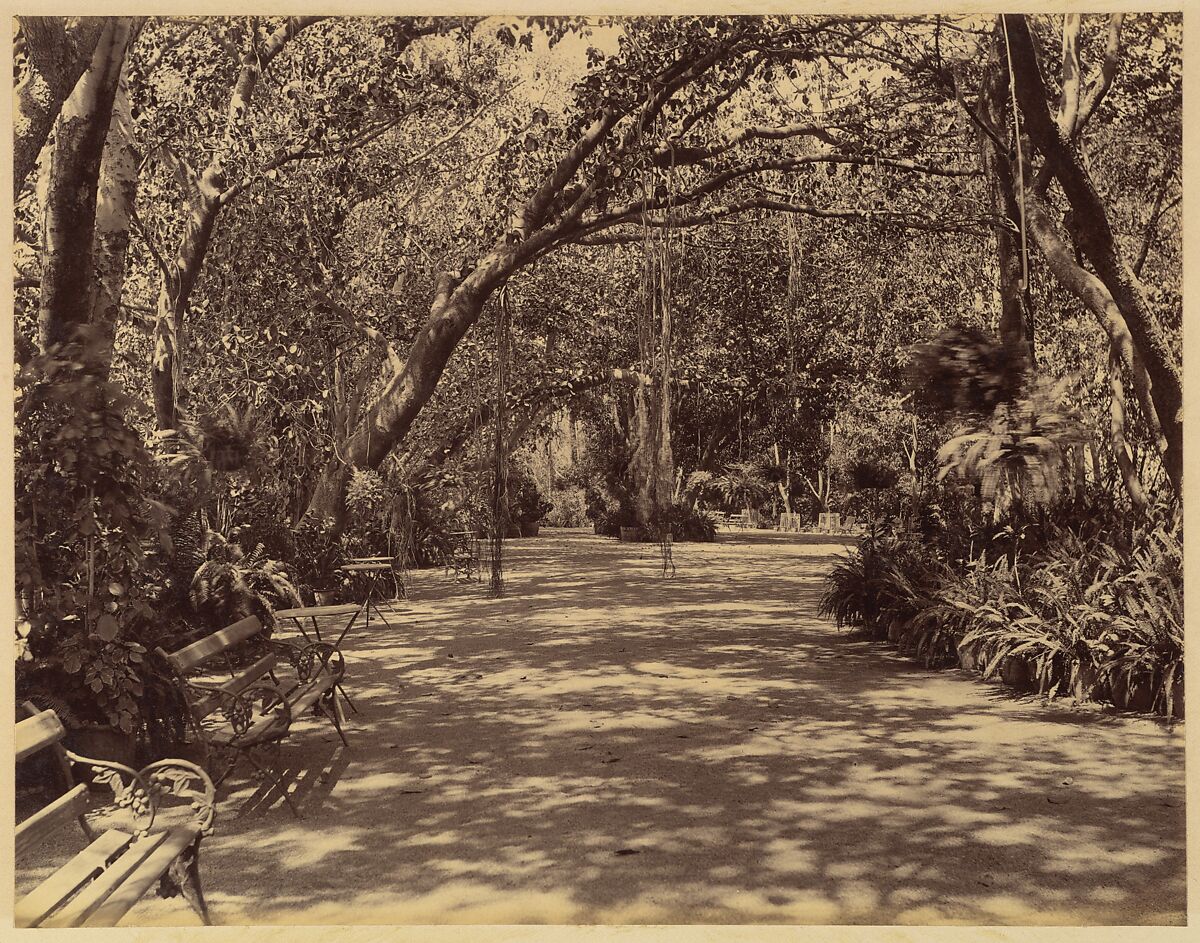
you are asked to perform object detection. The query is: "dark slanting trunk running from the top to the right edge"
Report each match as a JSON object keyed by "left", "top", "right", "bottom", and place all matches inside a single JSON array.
[{"left": 1003, "top": 13, "right": 1183, "bottom": 494}]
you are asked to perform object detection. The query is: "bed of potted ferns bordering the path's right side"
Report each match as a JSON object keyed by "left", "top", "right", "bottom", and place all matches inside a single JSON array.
[{"left": 821, "top": 484, "right": 1183, "bottom": 715}]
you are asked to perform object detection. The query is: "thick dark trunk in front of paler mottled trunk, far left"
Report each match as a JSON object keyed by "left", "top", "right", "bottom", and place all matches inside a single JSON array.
[{"left": 38, "top": 17, "right": 134, "bottom": 349}]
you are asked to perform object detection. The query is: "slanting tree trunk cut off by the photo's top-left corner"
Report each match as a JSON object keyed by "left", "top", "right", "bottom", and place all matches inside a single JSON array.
[{"left": 12, "top": 17, "right": 106, "bottom": 199}]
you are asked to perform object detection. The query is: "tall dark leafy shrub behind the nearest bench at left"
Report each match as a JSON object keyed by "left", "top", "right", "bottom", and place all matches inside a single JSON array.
[{"left": 14, "top": 331, "right": 189, "bottom": 747}]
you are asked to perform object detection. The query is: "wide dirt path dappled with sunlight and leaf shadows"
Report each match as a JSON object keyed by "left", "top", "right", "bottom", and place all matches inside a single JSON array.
[{"left": 21, "top": 531, "right": 1184, "bottom": 924}]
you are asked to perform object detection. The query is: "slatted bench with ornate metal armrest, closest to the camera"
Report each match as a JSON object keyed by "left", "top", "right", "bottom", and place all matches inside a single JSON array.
[{"left": 13, "top": 703, "right": 216, "bottom": 927}]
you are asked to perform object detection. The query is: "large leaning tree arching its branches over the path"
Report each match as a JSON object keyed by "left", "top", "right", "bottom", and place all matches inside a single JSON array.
[{"left": 300, "top": 17, "right": 977, "bottom": 518}]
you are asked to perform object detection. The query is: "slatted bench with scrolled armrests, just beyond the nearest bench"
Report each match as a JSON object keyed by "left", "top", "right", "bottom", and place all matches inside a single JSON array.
[{"left": 160, "top": 615, "right": 349, "bottom": 818}]
